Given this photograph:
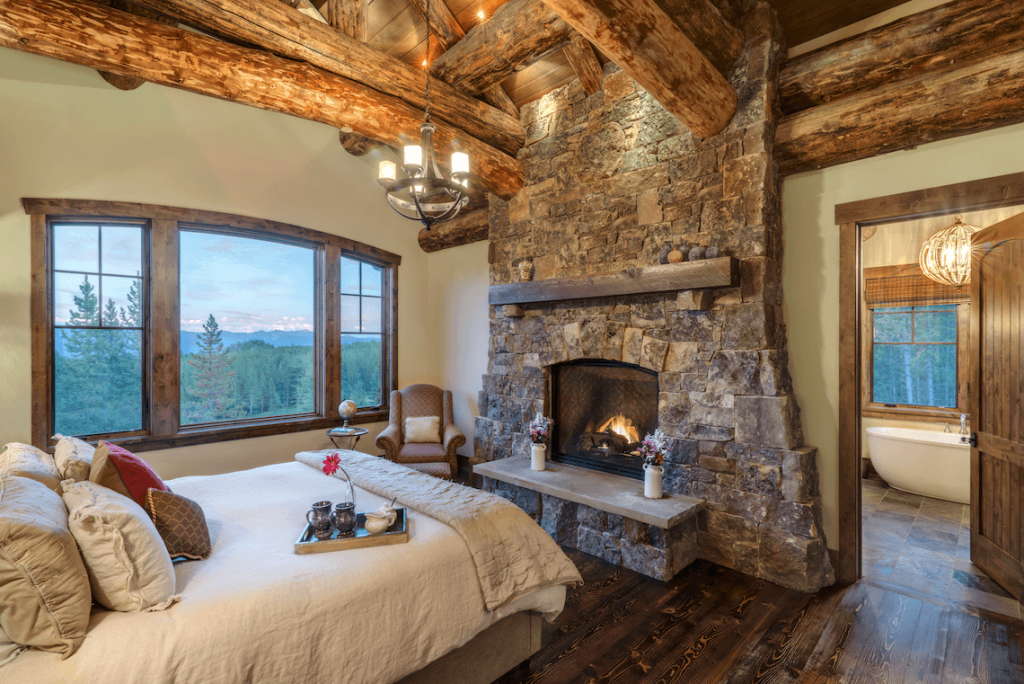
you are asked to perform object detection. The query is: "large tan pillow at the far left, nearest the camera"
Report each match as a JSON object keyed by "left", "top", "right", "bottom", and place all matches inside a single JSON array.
[{"left": 0, "top": 476, "right": 92, "bottom": 657}]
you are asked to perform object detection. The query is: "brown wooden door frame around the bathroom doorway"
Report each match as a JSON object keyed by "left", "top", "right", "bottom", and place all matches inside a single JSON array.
[{"left": 836, "top": 172, "right": 1024, "bottom": 583}]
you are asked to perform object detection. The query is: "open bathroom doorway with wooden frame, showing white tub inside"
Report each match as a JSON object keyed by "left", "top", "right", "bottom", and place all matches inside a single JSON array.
[{"left": 836, "top": 174, "right": 1024, "bottom": 617}]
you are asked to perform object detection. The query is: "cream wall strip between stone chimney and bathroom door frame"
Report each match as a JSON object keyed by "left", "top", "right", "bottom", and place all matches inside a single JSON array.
[{"left": 782, "top": 125, "right": 1024, "bottom": 548}]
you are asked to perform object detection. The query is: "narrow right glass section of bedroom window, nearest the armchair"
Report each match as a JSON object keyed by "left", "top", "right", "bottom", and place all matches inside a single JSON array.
[{"left": 341, "top": 256, "right": 384, "bottom": 408}]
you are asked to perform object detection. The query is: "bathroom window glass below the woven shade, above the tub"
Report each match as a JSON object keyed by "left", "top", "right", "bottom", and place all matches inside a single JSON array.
[{"left": 871, "top": 304, "right": 957, "bottom": 409}]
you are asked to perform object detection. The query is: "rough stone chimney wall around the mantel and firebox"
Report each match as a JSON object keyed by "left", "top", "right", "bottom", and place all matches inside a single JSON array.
[{"left": 474, "top": 0, "right": 834, "bottom": 591}]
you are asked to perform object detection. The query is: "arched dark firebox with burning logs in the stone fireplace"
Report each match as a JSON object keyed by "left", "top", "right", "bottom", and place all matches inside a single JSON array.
[{"left": 550, "top": 359, "right": 657, "bottom": 479}]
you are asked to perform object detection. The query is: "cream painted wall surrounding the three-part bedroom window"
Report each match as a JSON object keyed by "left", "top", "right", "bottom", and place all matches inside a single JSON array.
[{"left": 0, "top": 48, "right": 438, "bottom": 478}]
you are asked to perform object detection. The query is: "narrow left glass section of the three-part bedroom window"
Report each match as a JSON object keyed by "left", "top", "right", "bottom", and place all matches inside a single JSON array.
[{"left": 51, "top": 223, "right": 145, "bottom": 435}]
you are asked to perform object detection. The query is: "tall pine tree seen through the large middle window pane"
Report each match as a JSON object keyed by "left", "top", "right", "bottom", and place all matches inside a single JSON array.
[{"left": 183, "top": 313, "right": 241, "bottom": 424}]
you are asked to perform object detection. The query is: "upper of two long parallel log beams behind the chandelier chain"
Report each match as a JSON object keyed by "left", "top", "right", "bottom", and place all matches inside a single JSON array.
[{"left": 129, "top": 0, "right": 525, "bottom": 155}]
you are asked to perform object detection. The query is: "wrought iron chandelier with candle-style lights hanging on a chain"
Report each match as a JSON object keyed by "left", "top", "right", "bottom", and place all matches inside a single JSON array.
[{"left": 377, "top": 0, "right": 469, "bottom": 230}]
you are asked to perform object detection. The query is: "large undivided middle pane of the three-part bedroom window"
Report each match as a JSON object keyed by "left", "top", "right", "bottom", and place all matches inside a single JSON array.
[{"left": 179, "top": 230, "right": 316, "bottom": 425}]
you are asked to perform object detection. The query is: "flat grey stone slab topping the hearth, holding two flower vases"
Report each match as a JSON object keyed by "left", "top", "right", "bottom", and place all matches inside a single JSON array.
[{"left": 473, "top": 458, "right": 705, "bottom": 529}]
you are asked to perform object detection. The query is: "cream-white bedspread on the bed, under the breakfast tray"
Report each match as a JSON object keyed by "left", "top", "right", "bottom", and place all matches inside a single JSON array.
[{"left": 0, "top": 462, "right": 565, "bottom": 684}]
